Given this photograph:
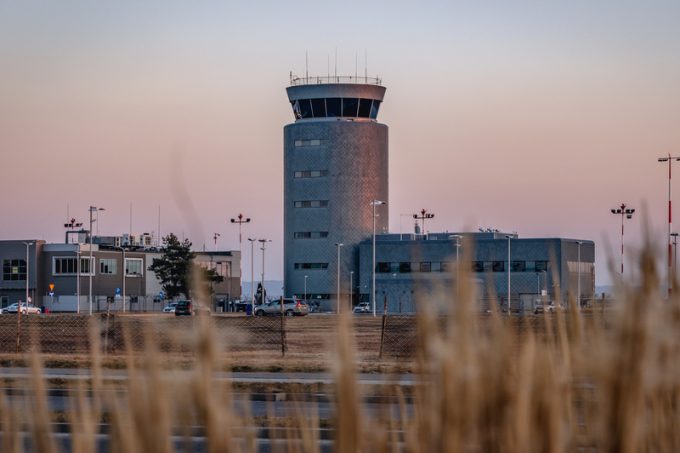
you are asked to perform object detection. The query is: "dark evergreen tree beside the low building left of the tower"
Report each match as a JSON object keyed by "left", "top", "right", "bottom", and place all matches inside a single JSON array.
[{"left": 149, "top": 233, "right": 196, "bottom": 299}]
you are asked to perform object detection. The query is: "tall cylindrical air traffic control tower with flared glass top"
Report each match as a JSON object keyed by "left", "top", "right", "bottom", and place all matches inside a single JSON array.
[{"left": 283, "top": 76, "right": 389, "bottom": 310}]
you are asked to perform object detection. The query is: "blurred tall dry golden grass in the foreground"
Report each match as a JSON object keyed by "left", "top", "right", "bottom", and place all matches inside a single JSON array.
[{"left": 0, "top": 240, "right": 680, "bottom": 453}]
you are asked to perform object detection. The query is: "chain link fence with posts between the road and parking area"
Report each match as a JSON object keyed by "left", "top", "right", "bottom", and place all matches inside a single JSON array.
[{"left": 0, "top": 308, "right": 604, "bottom": 360}]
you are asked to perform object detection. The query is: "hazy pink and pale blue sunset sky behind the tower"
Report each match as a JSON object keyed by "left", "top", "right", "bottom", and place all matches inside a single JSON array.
[{"left": 0, "top": 0, "right": 680, "bottom": 284}]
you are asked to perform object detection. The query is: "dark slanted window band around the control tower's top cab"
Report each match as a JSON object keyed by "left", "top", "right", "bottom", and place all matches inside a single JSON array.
[{"left": 290, "top": 98, "right": 380, "bottom": 119}]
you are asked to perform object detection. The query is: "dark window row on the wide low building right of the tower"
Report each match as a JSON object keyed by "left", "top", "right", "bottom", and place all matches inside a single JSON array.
[{"left": 375, "top": 261, "right": 549, "bottom": 274}]
